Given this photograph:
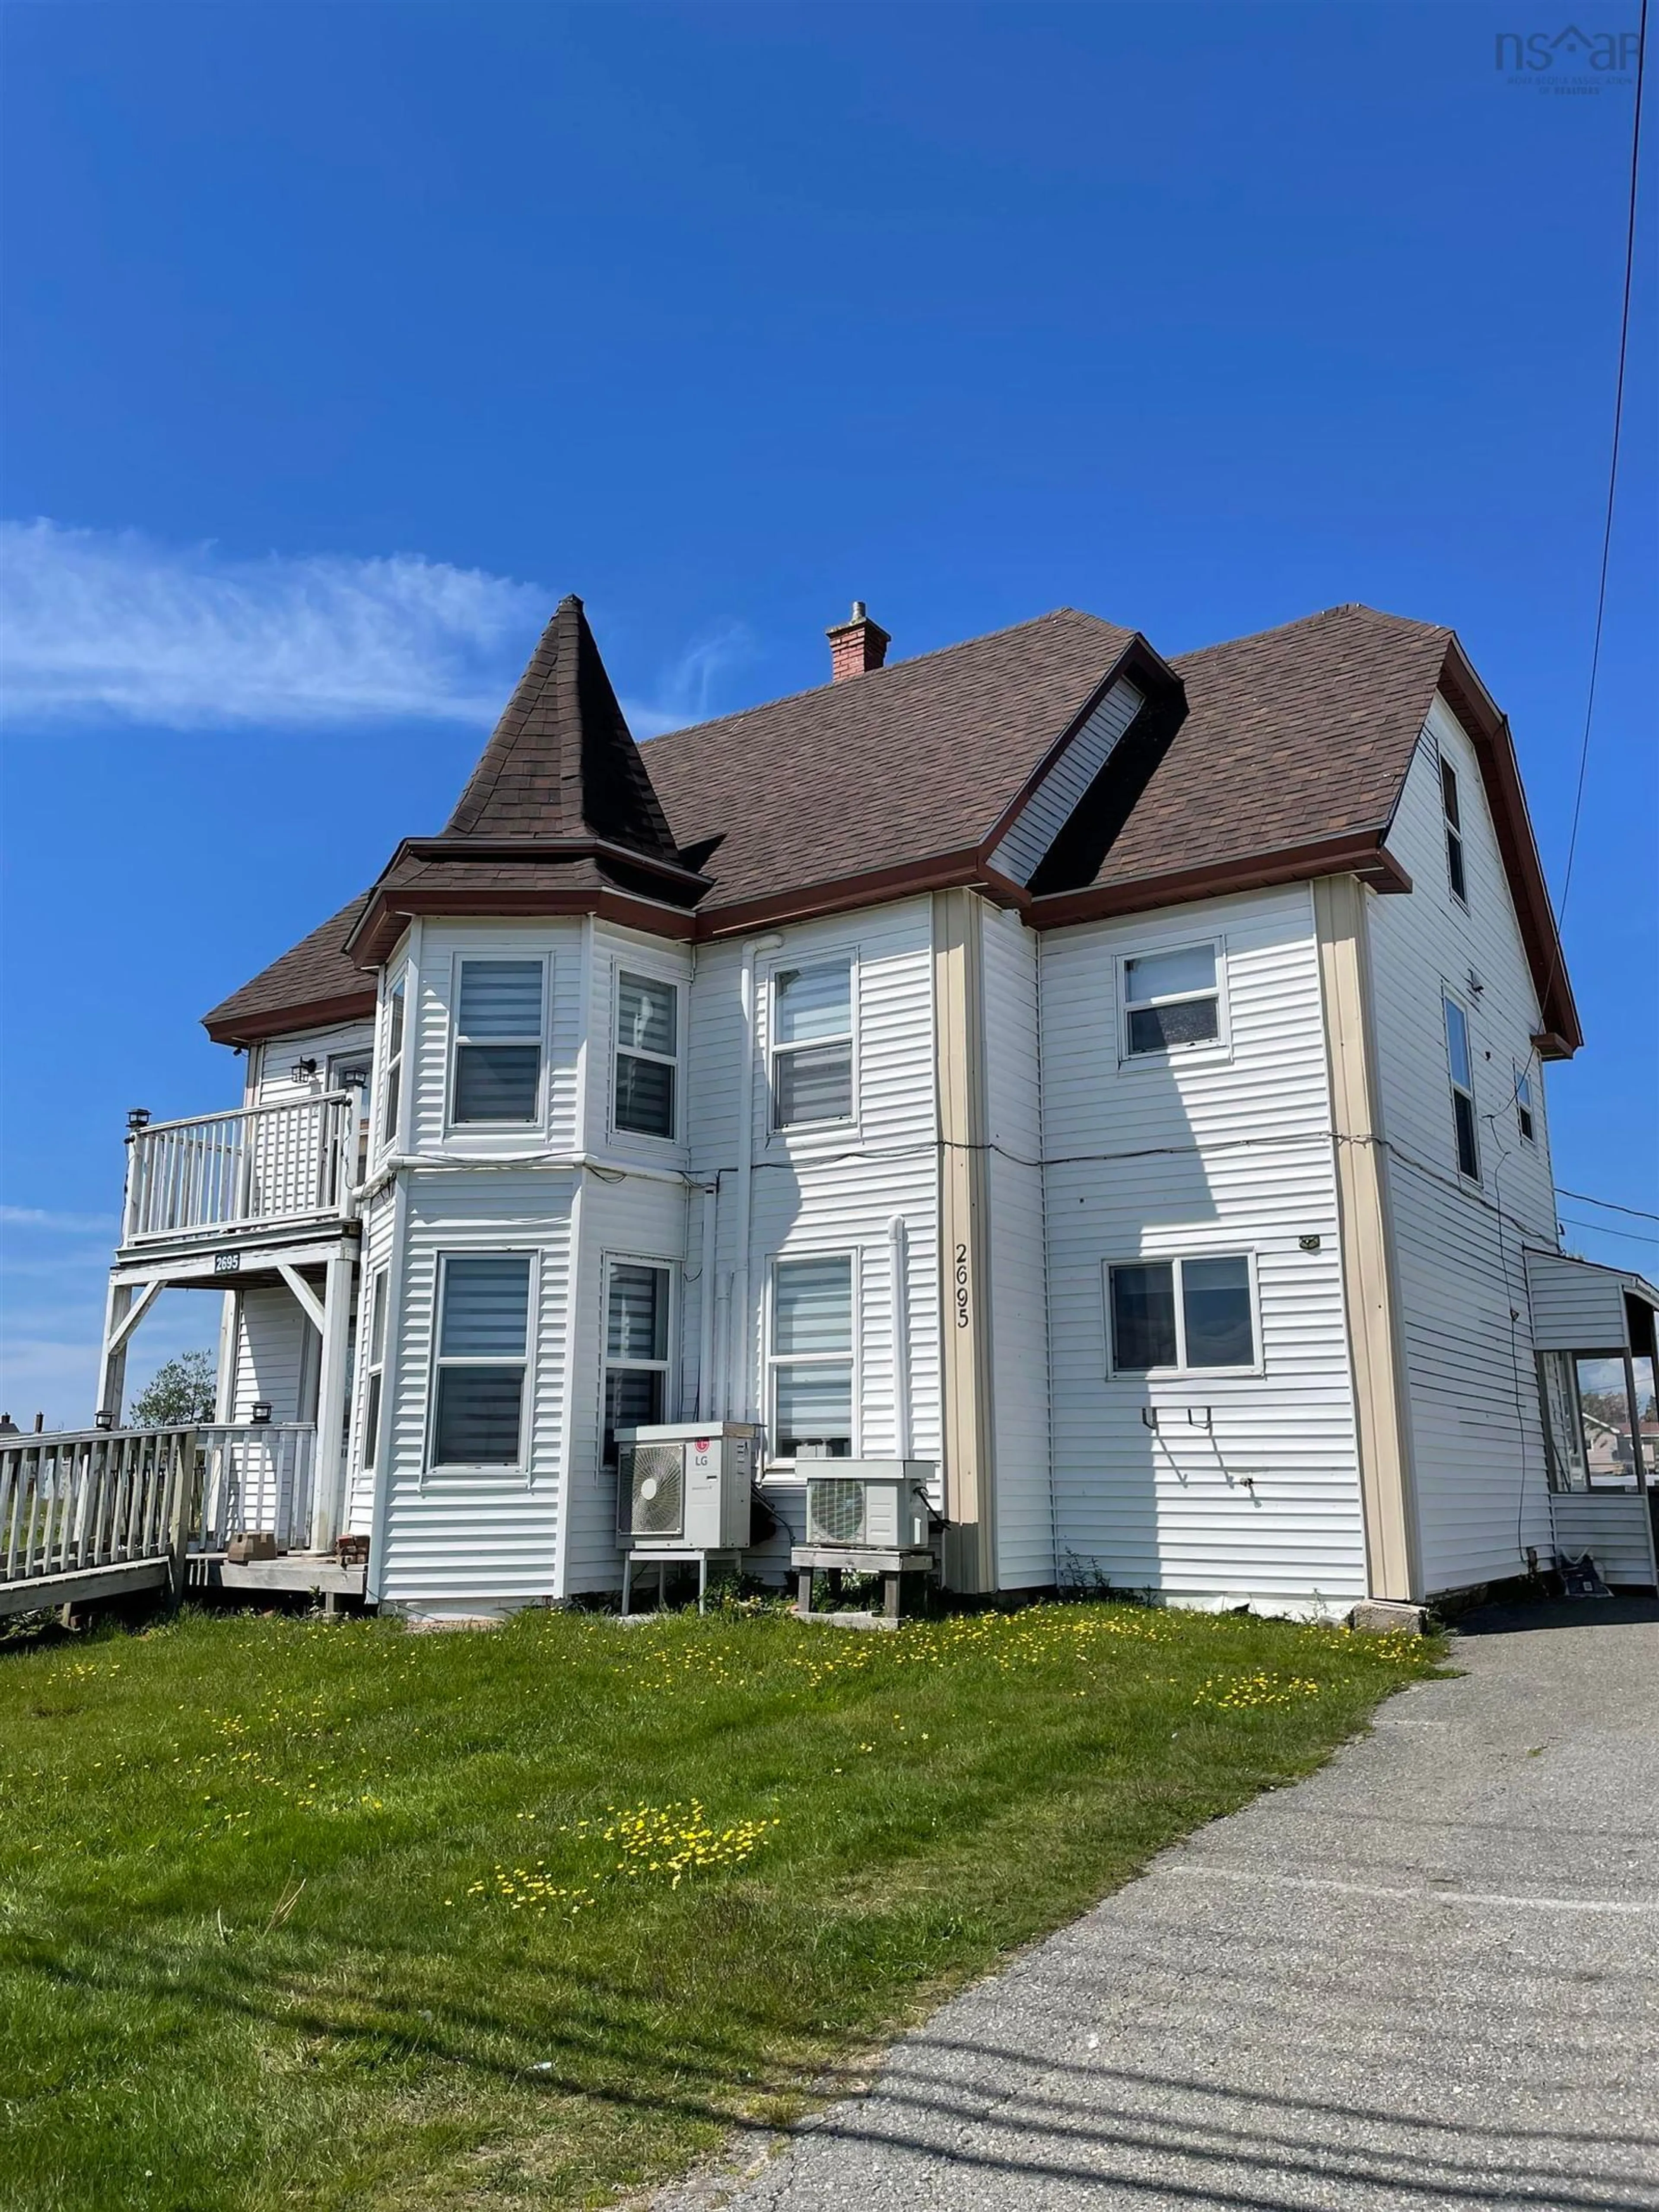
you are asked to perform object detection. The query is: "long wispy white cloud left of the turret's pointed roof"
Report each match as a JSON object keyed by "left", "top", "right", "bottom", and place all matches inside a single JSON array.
[{"left": 0, "top": 520, "right": 547, "bottom": 730}]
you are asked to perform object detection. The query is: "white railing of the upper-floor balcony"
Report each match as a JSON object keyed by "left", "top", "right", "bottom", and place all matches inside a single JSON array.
[{"left": 122, "top": 1091, "right": 358, "bottom": 1245}]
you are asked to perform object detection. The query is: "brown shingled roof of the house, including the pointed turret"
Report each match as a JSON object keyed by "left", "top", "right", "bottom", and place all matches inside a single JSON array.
[{"left": 208, "top": 597, "right": 1580, "bottom": 1051}]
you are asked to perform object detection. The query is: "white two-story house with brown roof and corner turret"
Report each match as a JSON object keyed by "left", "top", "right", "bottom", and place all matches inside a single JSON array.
[{"left": 81, "top": 599, "right": 1655, "bottom": 1615}]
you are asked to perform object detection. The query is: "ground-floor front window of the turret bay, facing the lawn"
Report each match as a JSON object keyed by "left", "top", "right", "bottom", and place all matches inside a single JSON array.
[{"left": 431, "top": 1252, "right": 531, "bottom": 1467}]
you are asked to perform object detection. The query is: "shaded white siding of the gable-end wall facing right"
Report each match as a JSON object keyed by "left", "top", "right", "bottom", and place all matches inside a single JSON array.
[{"left": 1369, "top": 701, "right": 1555, "bottom": 1591}]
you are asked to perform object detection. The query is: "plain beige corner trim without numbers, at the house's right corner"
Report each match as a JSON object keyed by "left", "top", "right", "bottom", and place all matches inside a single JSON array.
[{"left": 1314, "top": 876, "right": 1422, "bottom": 1599}]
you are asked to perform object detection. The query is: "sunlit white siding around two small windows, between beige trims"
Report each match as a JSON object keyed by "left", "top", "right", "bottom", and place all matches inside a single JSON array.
[{"left": 1042, "top": 885, "right": 1365, "bottom": 1608}]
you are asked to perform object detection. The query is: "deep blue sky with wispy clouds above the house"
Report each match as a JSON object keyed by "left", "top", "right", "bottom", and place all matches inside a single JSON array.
[{"left": 0, "top": 0, "right": 1659, "bottom": 1420}]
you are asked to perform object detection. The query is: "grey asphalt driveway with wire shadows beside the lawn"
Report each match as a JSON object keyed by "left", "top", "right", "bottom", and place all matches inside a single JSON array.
[{"left": 661, "top": 1601, "right": 1659, "bottom": 2212}]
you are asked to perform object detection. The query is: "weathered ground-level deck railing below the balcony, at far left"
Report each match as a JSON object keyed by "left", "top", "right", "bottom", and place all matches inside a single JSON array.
[{"left": 0, "top": 1423, "right": 316, "bottom": 1586}]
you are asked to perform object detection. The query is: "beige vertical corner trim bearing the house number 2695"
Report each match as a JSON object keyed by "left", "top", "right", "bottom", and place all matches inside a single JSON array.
[{"left": 934, "top": 891, "right": 995, "bottom": 1591}]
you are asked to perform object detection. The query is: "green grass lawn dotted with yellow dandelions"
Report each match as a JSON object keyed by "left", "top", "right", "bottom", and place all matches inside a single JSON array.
[{"left": 0, "top": 1604, "right": 1436, "bottom": 2212}]
